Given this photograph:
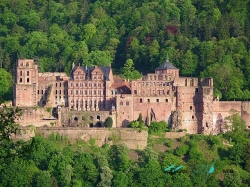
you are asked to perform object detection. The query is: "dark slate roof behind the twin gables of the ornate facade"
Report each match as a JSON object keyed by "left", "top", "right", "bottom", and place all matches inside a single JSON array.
[{"left": 70, "top": 66, "right": 111, "bottom": 81}]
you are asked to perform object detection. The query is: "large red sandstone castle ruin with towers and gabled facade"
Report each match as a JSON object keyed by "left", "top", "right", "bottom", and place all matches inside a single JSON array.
[{"left": 13, "top": 58, "right": 250, "bottom": 134}]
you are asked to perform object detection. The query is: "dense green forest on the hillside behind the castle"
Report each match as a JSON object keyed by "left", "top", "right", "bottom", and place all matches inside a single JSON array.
[{"left": 0, "top": 0, "right": 250, "bottom": 100}]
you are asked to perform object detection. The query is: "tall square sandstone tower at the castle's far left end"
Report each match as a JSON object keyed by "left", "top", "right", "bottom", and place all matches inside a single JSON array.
[{"left": 13, "top": 59, "right": 38, "bottom": 107}]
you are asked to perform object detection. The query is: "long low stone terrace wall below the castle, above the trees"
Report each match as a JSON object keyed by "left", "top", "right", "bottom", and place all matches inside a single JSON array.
[{"left": 16, "top": 127, "right": 148, "bottom": 149}]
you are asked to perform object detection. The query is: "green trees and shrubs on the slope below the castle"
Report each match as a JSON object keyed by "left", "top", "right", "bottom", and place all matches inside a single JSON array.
[{"left": 0, "top": 105, "right": 250, "bottom": 187}]
